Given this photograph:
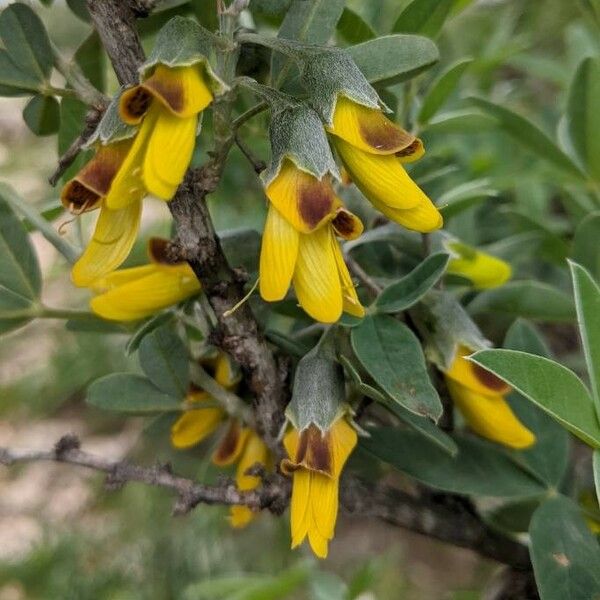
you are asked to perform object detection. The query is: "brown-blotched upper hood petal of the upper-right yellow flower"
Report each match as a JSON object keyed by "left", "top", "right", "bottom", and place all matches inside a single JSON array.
[{"left": 327, "top": 96, "right": 415, "bottom": 154}]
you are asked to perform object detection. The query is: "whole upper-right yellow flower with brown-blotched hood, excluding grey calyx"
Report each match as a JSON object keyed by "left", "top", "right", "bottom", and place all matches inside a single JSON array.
[{"left": 327, "top": 95, "right": 443, "bottom": 232}]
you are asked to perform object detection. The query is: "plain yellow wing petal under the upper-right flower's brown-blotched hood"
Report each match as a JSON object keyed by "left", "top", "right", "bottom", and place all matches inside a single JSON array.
[{"left": 335, "top": 139, "right": 430, "bottom": 210}]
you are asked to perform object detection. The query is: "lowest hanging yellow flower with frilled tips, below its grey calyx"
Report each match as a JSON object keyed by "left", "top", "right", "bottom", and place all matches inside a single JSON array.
[{"left": 281, "top": 417, "right": 357, "bottom": 558}]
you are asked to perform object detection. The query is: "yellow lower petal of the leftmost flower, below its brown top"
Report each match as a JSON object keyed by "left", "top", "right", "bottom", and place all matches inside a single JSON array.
[{"left": 71, "top": 200, "right": 142, "bottom": 287}]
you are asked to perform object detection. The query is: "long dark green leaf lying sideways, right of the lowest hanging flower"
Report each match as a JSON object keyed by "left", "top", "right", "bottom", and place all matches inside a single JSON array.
[{"left": 360, "top": 427, "right": 545, "bottom": 498}]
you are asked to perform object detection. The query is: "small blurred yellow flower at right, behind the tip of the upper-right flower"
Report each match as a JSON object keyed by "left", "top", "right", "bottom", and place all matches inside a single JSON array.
[{"left": 446, "top": 241, "right": 512, "bottom": 290}]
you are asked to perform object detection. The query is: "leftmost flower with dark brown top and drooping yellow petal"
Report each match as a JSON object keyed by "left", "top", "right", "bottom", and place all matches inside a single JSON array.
[{"left": 61, "top": 140, "right": 142, "bottom": 287}]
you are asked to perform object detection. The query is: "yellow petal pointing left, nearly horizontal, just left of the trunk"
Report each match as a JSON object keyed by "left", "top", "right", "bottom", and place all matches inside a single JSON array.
[{"left": 90, "top": 264, "right": 200, "bottom": 321}]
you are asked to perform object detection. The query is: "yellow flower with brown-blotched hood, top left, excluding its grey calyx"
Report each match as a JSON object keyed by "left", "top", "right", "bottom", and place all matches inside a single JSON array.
[{"left": 106, "top": 64, "right": 213, "bottom": 210}]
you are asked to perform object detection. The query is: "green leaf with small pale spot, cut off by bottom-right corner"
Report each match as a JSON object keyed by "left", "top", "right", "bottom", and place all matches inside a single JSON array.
[{"left": 529, "top": 496, "right": 600, "bottom": 600}]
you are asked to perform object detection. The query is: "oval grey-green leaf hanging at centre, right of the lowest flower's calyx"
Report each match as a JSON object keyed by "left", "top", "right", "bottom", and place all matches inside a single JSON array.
[{"left": 351, "top": 315, "right": 443, "bottom": 421}]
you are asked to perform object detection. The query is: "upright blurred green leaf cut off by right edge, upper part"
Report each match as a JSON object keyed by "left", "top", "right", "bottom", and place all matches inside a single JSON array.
[{"left": 566, "top": 57, "right": 600, "bottom": 182}]
